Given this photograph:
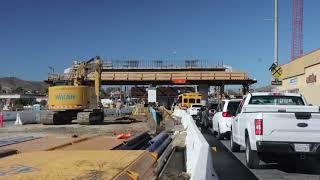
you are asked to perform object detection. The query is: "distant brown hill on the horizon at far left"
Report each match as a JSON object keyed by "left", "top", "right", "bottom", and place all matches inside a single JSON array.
[{"left": 0, "top": 77, "right": 47, "bottom": 93}]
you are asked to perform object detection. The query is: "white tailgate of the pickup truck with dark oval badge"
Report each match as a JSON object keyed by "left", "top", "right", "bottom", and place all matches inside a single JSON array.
[{"left": 244, "top": 105, "right": 320, "bottom": 142}]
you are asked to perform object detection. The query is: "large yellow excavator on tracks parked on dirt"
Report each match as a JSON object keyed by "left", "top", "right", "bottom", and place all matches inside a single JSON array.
[{"left": 40, "top": 56, "right": 104, "bottom": 125}]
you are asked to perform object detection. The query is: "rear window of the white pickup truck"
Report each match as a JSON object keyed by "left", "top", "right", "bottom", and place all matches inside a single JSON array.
[{"left": 249, "top": 96, "right": 305, "bottom": 106}]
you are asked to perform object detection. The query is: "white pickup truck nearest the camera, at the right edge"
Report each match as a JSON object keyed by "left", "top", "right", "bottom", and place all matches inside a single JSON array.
[{"left": 230, "top": 92, "right": 320, "bottom": 168}]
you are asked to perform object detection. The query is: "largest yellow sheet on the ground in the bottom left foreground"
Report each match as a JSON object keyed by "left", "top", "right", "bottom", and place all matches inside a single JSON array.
[{"left": 0, "top": 151, "right": 144, "bottom": 180}]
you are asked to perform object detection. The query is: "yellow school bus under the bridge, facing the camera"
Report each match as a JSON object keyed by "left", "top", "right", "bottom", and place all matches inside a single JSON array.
[{"left": 178, "top": 92, "right": 202, "bottom": 108}]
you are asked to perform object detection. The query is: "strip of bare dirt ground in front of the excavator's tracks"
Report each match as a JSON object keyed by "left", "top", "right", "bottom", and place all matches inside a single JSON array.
[{"left": 0, "top": 116, "right": 149, "bottom": 137}]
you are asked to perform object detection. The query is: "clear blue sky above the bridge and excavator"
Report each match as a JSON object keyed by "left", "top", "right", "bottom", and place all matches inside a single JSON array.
[{"left": 0, "top": 0, "right": 320, "bottom": 84}]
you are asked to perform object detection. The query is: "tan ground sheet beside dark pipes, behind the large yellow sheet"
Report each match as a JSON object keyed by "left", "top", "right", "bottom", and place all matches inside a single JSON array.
[{"left": 59, "top": 136, "right": 123, "bottom": 151}]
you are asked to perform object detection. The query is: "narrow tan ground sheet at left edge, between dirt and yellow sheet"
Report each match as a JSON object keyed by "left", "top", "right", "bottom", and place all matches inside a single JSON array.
[{"left": 0, "top": 136, "right": 88, "bottom": 152}]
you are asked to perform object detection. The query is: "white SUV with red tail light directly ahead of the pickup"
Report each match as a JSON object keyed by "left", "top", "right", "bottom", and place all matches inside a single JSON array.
[{"left": 212, "top": 99, "right": 241, "bottom": 140}]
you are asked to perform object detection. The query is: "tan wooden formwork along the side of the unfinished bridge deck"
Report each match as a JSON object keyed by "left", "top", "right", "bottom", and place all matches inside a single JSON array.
[{"left": 46, "top": 65, "right": 257, "bottom": 86}]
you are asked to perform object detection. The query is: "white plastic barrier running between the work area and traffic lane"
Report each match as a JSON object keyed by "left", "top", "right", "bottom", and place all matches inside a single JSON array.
[{"left": 173, "top": 109, "right": 218, "bottom": 180}]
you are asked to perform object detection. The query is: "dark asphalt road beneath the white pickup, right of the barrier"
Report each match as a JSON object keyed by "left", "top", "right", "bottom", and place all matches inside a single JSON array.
[{"left": 203, "top": 131, "right": 320, "bottom": 180}]
